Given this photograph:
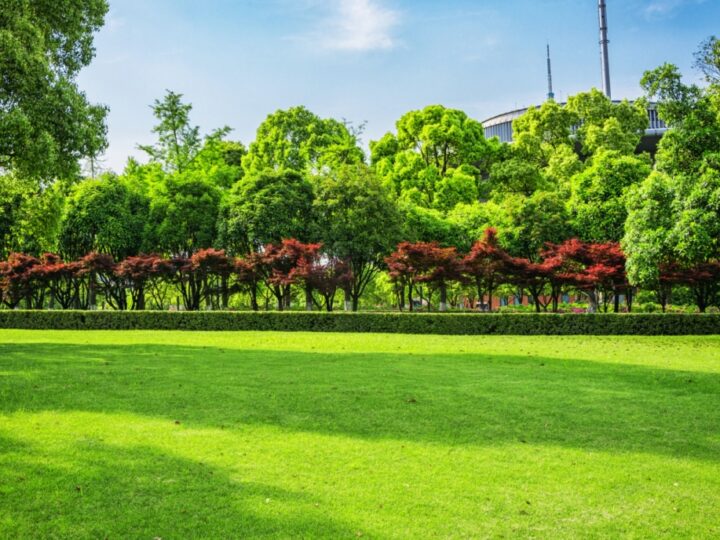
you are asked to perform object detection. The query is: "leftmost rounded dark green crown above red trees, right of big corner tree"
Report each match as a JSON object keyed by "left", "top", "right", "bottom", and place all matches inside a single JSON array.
[{"left": 58, "top": 174, "right": 148, "bottom": 260}]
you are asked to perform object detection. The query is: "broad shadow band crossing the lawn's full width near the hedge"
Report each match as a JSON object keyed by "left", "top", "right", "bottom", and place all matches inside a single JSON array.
[{"left": 0, "top": 343, "right": 720, "bottom": 461}]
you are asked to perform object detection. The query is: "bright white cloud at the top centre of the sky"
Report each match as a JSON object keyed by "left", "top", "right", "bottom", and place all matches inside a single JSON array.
[{"left": 313, "top": 0, "right": 400, "bottom": 52}]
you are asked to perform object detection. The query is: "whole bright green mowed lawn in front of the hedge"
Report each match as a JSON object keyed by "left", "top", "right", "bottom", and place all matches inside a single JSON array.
[{"left": 0, "top": 330, "right": 720, "bottom": 540}]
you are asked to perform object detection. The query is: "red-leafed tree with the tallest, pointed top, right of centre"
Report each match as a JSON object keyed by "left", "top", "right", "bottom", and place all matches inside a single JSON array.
[{"left": 462, "top": 227, "right": 510, "bottom": 311}]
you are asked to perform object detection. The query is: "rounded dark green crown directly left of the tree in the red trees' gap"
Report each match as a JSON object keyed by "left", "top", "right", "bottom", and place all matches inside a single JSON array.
[{"left": 218, "top": 170, "right": 313, "bottom": 253}]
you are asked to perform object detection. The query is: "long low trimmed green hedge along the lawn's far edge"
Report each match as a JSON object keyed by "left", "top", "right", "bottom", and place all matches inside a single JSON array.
[{"left": 0, "top": 310, "right": 720, "bottom": 335}]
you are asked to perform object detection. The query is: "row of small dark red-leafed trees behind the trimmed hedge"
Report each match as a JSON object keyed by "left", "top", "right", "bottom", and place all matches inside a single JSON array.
[{"left": 0, "top": 229, "right": 720, "bottom": 313}]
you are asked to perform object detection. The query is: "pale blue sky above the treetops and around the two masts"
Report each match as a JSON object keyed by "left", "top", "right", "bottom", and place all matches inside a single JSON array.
[{"left": 79, "top": 0, "right": 720, "bottom": 171}]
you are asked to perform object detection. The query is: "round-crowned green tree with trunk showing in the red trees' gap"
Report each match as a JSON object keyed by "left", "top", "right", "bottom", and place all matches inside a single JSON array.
[{"left": 313, "top": 164, "right": 400, "bottom": 311}]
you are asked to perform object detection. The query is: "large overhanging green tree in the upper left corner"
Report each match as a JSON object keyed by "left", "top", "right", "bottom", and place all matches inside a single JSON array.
[{"left": 0, "top": 0, "right": 108, "bottom": 181}]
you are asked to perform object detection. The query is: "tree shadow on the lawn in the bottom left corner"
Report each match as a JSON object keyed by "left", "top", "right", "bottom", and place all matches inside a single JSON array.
[{"left": 0, "top": 439, "right": 354, "bottom": 538}]
